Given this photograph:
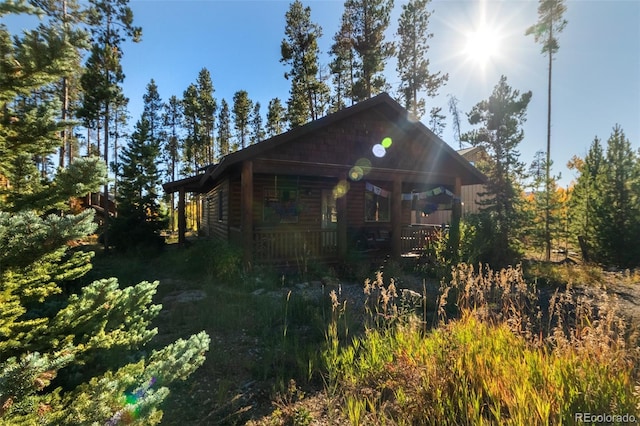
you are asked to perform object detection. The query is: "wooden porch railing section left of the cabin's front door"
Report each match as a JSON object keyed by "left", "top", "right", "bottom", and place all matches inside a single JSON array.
[{"left": 254, "top": 229, "right": 338, "bottom": 262}]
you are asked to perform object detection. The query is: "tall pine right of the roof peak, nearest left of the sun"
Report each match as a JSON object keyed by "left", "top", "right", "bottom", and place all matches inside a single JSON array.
[{"left": 396, "top": 0, "right": 449, "bottom": 119}]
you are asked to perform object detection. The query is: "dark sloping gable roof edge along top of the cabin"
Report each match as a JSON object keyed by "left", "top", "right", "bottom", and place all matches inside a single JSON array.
[{"left": 163, "top": 93, "right": 486, "bottom": 192}]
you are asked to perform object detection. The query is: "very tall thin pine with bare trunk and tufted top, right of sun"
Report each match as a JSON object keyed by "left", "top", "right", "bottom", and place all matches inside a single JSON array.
[{"left": 526, "top": 0, "right": 567, "bottom": 261}]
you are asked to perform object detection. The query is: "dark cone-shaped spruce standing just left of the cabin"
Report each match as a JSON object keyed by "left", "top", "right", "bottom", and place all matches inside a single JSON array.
[{"left": 111, "top": 115, "right": 166, "bottom": 251}]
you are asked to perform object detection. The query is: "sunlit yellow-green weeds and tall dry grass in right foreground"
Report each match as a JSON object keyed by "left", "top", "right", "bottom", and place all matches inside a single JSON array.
[{"left": 324, "top": 265, "right": 640, "bottom": 425}]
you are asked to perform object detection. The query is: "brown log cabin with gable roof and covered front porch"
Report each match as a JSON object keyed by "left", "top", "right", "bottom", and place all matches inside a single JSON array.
[{"left": 164, "top": 94, "right": 484, "bottom": 265}]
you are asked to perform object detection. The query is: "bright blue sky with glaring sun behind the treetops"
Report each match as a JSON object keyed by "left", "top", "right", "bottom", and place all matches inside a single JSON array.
[{"left": 6, "top": 0, "right": 640, "bottom": 185}]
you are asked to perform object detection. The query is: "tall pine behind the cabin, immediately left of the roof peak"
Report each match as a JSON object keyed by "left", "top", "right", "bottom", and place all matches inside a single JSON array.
[{"left": 345, "top": 0, "right": 394, "bottom": 102}]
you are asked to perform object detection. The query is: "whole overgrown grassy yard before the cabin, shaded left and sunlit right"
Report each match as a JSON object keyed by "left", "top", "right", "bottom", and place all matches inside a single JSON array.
[{"left": 76, "top": 240, "right": 638, "bottom": 425}]
